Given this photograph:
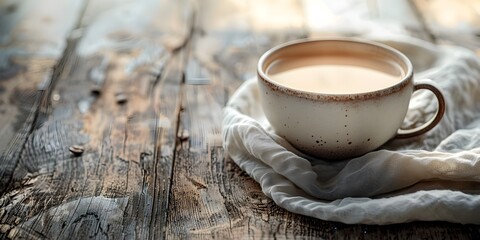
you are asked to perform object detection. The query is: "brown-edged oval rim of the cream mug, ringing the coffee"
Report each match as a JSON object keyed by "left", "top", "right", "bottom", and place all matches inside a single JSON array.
[{"left": 257, "top": 37, "right": 413, "bottom": 101}]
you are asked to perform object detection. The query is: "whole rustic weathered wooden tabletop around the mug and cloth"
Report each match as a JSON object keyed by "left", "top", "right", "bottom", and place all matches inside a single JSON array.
[{"left": 0, "top": 0, "right": 480, "bottom": 239}]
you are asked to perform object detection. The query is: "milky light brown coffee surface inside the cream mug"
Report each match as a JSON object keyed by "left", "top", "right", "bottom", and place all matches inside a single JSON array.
[{"left": 266, "top": 56, "right": 403, "bottom": 94}]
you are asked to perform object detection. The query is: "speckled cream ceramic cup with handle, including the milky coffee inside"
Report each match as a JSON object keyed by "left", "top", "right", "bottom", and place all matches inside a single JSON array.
[{"left": 257, "top": 38, "right": 445, "bottom": 160}]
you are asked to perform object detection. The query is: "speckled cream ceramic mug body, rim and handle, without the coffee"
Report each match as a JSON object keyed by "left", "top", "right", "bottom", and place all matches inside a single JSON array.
[{"left": 257, "top": 39, "right": 445, "bottom": 160}]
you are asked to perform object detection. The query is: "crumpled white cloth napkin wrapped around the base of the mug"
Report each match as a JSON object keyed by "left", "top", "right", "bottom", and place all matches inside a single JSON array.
[{"left": 223, "top": 38, "right": 480, "bottom": 224}]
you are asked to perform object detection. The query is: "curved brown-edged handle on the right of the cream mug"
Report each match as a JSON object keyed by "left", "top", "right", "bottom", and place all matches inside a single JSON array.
[{"left": 395, "top": 79, "right": 445, "bottom": 138}]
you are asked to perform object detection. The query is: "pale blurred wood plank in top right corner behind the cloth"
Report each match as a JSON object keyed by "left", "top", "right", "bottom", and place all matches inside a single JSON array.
[{"left": 411, "top": 0, "right": 480, "bottom": 53}]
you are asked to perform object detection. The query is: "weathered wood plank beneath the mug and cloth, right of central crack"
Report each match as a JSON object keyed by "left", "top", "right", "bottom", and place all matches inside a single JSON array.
[{"left": 167, "top": 1, "right": 480, "bottom": 239}]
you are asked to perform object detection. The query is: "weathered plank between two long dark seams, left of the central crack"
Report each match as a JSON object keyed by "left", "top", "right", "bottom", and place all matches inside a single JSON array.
[{"left": 0, "top": 1, "right": 190, "bottom": 239}]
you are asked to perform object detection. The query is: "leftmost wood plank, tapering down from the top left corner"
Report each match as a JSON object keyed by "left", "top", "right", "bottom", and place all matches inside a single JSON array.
[{"left": 0, "top": 0, "right": 87, "bottom": 193}]
